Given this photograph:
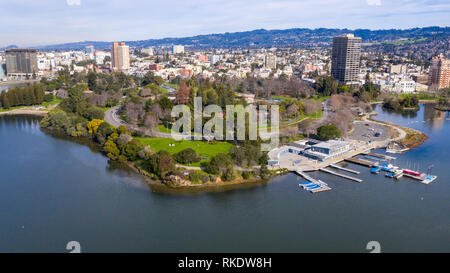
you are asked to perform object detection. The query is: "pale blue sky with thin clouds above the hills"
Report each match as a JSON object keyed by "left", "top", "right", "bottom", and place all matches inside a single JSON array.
[{"left": 0, "top": 0, "right": 450, "bottom": 46}]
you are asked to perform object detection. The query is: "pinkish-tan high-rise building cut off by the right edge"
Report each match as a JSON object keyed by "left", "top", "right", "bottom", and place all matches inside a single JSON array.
[{"left": 429, "top": 54, "right": 450, "bottom": 92}]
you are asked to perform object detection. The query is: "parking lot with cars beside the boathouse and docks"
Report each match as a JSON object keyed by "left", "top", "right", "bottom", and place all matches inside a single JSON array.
[{"left": 348, "top": 121, "right": 390, "bottom": 142}]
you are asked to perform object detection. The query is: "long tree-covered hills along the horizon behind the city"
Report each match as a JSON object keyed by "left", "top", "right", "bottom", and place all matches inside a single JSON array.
[{"left": 29, "top": 27, "right": 450, "bottom": 51}]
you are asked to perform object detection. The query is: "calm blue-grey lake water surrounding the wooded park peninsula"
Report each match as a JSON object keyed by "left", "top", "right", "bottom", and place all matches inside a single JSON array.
[{"left": 0, "top": 105, "right": 450, "bottom": 252}]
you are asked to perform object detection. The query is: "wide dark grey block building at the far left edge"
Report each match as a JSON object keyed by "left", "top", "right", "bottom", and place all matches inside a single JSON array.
[{"left": 5, "top": 48, "right": 38, "bottom": 76}]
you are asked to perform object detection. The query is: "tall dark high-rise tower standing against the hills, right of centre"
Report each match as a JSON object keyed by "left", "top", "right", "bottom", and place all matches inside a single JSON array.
[{"left": 331, "top": 34, "right": 361, "bottom": 84}]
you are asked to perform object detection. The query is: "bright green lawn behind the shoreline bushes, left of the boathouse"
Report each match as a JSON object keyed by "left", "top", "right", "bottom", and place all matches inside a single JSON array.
[{"left": 137, "top": 137, "right": 233, "bottom": 167}]
